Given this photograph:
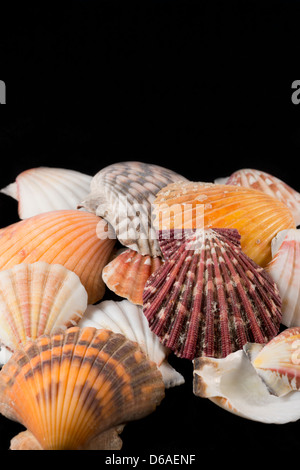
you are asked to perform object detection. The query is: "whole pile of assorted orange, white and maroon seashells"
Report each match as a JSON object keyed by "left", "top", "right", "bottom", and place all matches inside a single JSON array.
[{"left": 0, "top": 161, "right": 300, "bottom": 450}]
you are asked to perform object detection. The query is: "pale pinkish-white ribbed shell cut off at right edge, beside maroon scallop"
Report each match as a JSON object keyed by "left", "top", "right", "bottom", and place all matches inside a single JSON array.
[{"left": 266, "top": 229, "right": 300, "bottom": 327}]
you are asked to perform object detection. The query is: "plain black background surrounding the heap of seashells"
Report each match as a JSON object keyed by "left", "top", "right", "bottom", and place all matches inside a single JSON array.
[{"left": 0, "top": 0, "right": 300, "bottom": 458}]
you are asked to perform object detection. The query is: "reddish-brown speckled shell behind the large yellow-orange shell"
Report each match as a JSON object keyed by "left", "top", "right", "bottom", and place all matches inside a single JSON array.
[{"left": 220, "top": 168, "right": 300, "bottom": 225}]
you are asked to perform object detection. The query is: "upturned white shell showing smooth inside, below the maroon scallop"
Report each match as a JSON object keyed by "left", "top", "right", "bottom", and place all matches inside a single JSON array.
[{"left": 193, "top": 349, "right": 300, "bottom": 424}]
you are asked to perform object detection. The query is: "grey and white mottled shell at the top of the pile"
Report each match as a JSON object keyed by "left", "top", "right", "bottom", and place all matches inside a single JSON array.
[{"left": 78, "top": 161, "right": 187, "bottom": 257}]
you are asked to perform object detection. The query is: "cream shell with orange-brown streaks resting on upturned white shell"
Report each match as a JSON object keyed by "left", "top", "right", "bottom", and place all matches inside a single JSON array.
[{"left": 245, "top": 327, "right": 300, "bottom": 397}]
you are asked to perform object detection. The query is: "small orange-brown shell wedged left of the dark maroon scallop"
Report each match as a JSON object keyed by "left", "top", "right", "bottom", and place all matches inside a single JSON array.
[{"left": 102, "top": 248, "right": 162, "bottom": 305}]
